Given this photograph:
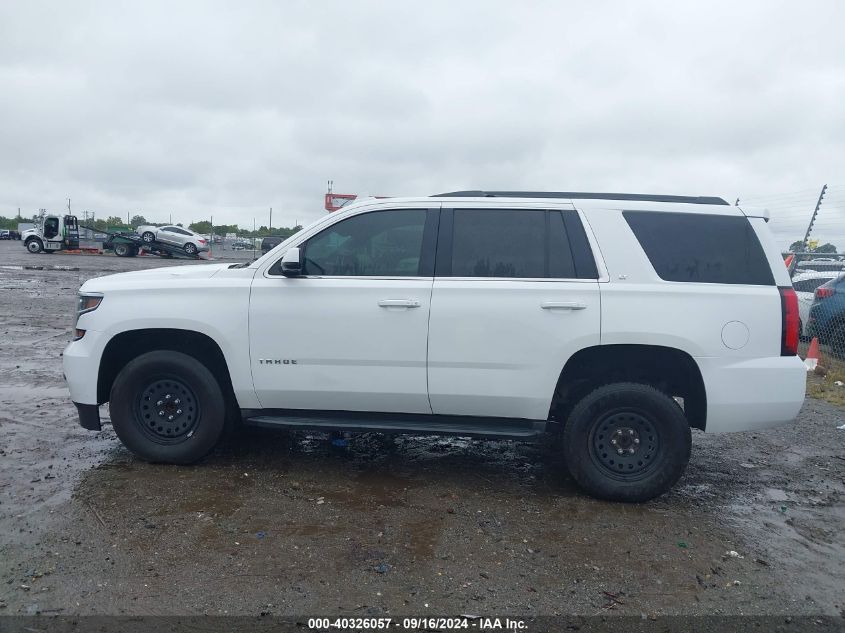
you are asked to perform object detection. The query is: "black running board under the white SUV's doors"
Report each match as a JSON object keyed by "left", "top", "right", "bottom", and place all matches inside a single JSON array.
[{"left": 242, "top": 409, "right": 548, "bottom": 440}]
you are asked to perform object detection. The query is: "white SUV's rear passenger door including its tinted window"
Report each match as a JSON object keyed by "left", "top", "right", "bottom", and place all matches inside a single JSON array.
[{"left": 428, "top": 204, "right": 600, "bottom": 420}]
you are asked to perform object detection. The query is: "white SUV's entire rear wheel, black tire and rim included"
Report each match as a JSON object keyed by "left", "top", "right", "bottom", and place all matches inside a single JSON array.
[{"left": 563, "top": 382, "right": 692, "bottom": 502}]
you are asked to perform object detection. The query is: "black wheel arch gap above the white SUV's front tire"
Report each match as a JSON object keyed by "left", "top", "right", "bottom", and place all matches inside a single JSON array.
[{"left": 97, "top": 328, "right": 238, "bottom": 407}]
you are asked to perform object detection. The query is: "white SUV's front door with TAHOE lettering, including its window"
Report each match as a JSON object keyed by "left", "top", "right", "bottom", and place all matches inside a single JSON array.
[{"left": 249, "top": 203, "right": 439, "bottom": 413}]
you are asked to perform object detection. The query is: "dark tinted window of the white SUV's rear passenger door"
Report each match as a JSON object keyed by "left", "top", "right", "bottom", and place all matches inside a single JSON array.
[{"left": 446, "top": 209, "right": 597, "bottom": 279}]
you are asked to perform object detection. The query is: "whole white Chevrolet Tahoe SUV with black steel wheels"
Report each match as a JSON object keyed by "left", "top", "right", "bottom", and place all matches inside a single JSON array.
[{"left": 64, "top": 191, "right": 805, "bottom": 501}]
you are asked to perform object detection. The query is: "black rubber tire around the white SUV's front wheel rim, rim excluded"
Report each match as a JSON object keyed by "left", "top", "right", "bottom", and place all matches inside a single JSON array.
[{"left": 109, "top": 350, "right": 226, "bottom": 464}]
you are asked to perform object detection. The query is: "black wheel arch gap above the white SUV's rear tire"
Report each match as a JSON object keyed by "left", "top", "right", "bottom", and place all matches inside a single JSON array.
[{"left": 549, "top": 344, "right": 707, "bottom": 431}]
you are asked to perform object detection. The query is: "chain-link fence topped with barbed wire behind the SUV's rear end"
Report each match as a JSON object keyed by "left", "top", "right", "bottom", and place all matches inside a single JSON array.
[{"left": 739, "top": 185, "right": 845, "bottom": 370}]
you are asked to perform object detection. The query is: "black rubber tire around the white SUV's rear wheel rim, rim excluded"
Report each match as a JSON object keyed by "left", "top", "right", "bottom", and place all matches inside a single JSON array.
[{"left": 563, "top": 383, "right": 692, "bottom": 502}]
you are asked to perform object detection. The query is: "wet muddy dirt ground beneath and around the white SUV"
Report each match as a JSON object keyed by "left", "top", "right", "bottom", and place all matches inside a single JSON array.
[{"left": 0, "top": 242, "right": 845, "bottom": 616}]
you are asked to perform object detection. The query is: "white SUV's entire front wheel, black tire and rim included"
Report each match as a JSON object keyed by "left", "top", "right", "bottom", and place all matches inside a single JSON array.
[{"left": 109, "top": 350, "right": 227, "bottom": 464}]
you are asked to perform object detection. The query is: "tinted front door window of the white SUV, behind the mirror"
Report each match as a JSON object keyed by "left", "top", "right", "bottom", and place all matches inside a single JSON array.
[{"left": 303, "top": 209, "right": 427, "bottom": 277}]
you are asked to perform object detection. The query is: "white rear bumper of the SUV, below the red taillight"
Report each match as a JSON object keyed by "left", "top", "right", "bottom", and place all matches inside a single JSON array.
[{"left": 695, "top": 356, "right": 807, "bottom": 433}]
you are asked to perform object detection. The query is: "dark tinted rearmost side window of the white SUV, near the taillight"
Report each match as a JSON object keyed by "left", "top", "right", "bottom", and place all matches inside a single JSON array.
[{"left": 622, "top": 211, "right": 775, "bottom": 286}]
